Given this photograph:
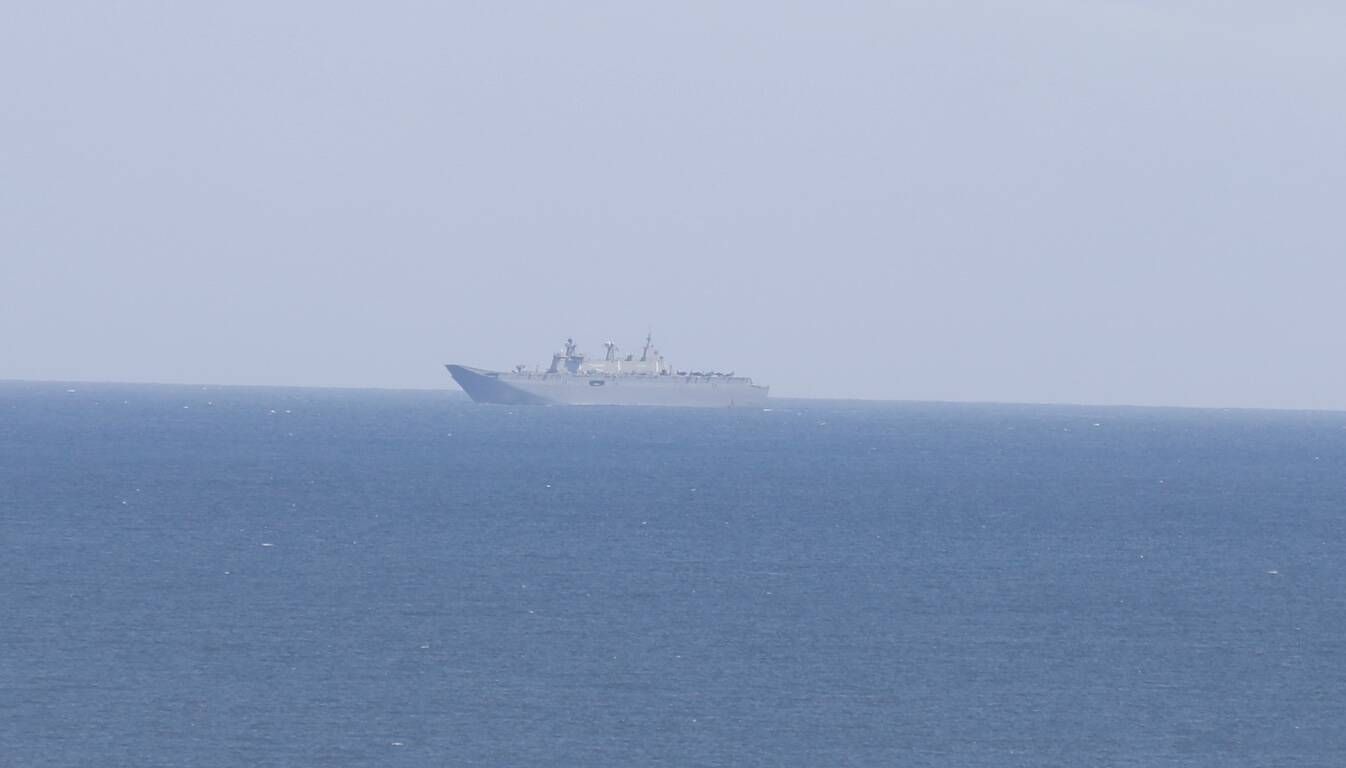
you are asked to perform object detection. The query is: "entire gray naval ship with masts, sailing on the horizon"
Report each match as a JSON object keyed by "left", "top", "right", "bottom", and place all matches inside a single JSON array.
[{"left": 444, "top": 336, "right": 769, "bottom": 408}]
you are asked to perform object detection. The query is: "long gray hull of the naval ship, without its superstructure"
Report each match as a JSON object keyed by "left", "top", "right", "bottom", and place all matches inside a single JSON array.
[{"left": 444, "top": 364, "right": 767, "bottom": 408}]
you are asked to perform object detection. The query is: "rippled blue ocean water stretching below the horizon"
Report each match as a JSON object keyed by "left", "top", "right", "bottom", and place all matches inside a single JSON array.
[{"left": 0, "top": 383, "right": 1346, "bottom": 767}]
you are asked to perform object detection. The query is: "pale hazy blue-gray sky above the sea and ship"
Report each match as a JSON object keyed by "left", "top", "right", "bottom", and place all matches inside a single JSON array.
[{"left": 0, "top": 0, "right": 1346, "bottom": 408}]
